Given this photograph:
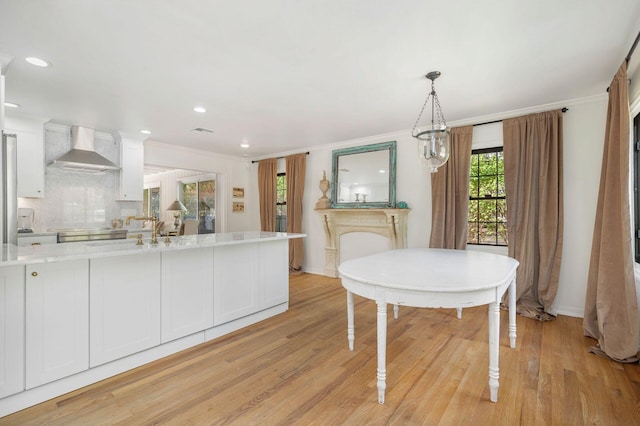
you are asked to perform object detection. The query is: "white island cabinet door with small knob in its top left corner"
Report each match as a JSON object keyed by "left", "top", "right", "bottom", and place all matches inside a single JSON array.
[{"left": 25, "top": 259, "right": 89, "bottom": 389}]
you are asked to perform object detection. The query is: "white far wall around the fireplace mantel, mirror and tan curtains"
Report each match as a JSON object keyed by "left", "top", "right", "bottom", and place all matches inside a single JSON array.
[{"left": 249, "top": 93, "right": 607, "bottom": 317}]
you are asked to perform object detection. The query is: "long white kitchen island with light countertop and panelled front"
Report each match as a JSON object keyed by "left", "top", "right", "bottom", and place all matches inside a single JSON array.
[{"left": 0, "top": 232, "right": 304, "bottom": 417}]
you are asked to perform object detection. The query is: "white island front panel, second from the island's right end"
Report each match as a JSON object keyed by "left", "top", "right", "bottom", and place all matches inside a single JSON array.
[{"left": 213, "top": 244, "right": 260, "bottom": 325}]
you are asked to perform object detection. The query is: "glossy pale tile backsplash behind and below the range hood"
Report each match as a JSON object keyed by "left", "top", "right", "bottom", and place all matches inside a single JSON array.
[{"left": 18, "top": 124, "right": 142, "bottom": 232}]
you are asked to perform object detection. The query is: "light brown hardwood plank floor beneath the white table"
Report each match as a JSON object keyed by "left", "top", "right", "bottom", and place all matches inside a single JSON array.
[{"left": 0, "top": 274, "right": 640, "bottom": 425}]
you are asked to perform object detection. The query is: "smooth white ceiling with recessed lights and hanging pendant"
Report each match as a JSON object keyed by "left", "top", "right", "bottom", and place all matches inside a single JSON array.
[{"left": 0, "top": 0, "right": 640, "bottom": 158}]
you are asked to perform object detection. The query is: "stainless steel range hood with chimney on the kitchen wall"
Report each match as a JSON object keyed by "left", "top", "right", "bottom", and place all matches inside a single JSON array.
[{"left": 51, "top": 126, "right": 120, "bottom": 173}]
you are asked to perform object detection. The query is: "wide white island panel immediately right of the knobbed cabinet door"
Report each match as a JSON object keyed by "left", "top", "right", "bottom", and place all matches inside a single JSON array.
[{"left": 89, "top": 252, "right": 161, "bottom": 367}]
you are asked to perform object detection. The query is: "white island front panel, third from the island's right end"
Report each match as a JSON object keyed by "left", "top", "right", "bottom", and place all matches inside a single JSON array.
[{"left": 162, "top": 248, "right": 213, "bottom": 343}]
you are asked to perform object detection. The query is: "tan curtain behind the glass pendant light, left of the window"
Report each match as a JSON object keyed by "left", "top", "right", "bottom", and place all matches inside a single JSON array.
[{"left": 429, "top": 126, "right": 473, "bottom": 250}]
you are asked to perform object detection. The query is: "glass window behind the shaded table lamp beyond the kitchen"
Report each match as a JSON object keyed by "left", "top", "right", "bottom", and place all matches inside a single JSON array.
[{"left": 179, "top": 175, "right": 216, "bottom": 234}]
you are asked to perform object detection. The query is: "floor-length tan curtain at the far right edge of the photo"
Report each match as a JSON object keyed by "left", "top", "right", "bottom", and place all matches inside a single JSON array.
[{"left": 583, "top": 61, "right": 639, "bottom": 362}]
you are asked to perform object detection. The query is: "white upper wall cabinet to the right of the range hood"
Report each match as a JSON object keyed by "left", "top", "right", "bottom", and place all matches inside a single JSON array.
[{"left": 118, "top": 138, "right": 144, "bottom": 201}]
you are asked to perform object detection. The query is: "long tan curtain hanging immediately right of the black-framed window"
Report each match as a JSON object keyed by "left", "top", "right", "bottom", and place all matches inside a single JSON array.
[{"left": 502, "top": 110, "right": 564, "bottom": 320}]
